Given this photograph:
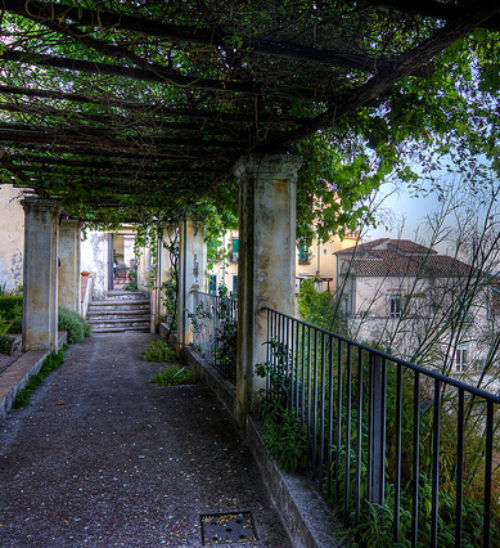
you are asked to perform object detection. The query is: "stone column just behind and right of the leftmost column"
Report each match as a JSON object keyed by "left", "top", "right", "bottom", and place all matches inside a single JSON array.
[{"left": 58, "top": 219, "right": 82, "bottom": 314}]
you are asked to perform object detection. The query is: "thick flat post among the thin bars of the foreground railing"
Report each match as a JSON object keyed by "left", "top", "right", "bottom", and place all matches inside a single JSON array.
[{"left": 368, "top": 354, "right": 386, "bottom": 505}]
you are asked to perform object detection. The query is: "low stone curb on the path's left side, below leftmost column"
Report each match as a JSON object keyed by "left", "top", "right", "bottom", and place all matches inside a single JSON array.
[{"left": 0, "top": 331, "right": 68, "bottom": 424}]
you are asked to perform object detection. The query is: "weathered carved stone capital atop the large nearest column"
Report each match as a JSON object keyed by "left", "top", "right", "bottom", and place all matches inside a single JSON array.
[{"left": 234, "top": 154, "right": 302, "bottom": 181}]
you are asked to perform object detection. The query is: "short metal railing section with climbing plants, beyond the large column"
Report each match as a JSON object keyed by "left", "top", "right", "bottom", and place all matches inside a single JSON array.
[{"left": 190, "top": 291, "right": 238, "bottom": 382}]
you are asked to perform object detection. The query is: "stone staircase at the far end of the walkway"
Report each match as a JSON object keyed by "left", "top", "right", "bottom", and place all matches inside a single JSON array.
[{"left": 87, "top": 290, "right": 151, "bottom": 333}]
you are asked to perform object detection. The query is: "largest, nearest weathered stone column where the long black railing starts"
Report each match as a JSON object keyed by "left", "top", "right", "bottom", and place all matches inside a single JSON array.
[{"left": 235, "top": 154, "right": 302, "bottom": 426}]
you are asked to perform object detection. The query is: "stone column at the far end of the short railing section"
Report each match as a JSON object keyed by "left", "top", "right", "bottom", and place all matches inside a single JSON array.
[{"left": 177, "top": 219, "right": 207, "bottom": 353}]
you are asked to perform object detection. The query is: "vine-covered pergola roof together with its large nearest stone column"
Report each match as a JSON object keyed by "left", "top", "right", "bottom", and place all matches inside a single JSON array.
[{"left": 0, "top": 0, "right": 500, "bottom": 422}]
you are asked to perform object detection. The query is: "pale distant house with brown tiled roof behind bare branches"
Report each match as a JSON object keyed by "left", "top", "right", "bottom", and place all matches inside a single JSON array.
[{"left": 335, "top": 238, "right": 500, "bottom": 373}]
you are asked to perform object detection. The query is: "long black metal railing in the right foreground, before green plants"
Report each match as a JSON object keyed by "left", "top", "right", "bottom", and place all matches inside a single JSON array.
[{"left": 266, "top": 309, "right": 500, "bottom": 548}]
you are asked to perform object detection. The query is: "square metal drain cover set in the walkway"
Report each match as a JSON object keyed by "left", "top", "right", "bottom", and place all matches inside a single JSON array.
[{"left": 201, "top": 512, "right": 257, "bottom": 545}]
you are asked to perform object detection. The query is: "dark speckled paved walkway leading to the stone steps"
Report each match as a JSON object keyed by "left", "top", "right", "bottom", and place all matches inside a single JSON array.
[{"left": 0, "top": 333, "right": 289, "bottom": 548}]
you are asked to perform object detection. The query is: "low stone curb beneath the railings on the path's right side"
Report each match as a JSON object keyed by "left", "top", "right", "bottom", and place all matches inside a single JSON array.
[{"left": 185, "top": 347, "right": 341, "bottom": 548}]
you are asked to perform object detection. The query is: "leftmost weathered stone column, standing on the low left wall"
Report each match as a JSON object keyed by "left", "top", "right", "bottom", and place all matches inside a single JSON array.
[{"left": 23, "top": 198, "right": 61, "bottom": 352}]
